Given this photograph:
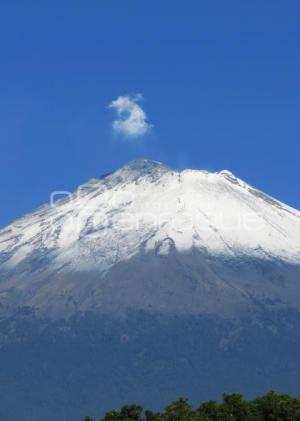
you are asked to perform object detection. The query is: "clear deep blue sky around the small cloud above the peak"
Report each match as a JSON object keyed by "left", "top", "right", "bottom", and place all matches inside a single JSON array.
[{"left": 0, "top": 0, "right": 300, "bottom": 226}]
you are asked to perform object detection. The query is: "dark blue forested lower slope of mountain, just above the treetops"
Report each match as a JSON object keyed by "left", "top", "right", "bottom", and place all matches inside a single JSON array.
[{"left": 0, "top": 309, "right": 300, "bottom": 421}]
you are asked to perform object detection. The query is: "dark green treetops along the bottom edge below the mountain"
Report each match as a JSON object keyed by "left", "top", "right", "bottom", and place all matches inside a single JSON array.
[{"left": 82, "top": 392, "right": 300, "bottom": 421}]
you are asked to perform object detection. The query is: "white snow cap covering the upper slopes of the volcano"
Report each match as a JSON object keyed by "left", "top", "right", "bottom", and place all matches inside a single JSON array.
[{"left": 0, "top": 160, "right": 300, "bottom": 316}]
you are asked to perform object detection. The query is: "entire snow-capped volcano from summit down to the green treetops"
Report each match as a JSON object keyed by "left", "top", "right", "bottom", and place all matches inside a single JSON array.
[{"left": 0, "top": 160, "right": 300, "bottom": 421}]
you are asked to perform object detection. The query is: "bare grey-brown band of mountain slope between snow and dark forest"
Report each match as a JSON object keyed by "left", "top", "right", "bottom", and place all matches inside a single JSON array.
[{"left": 0, "top": 243, "right": 300, "bottom": 319}]
